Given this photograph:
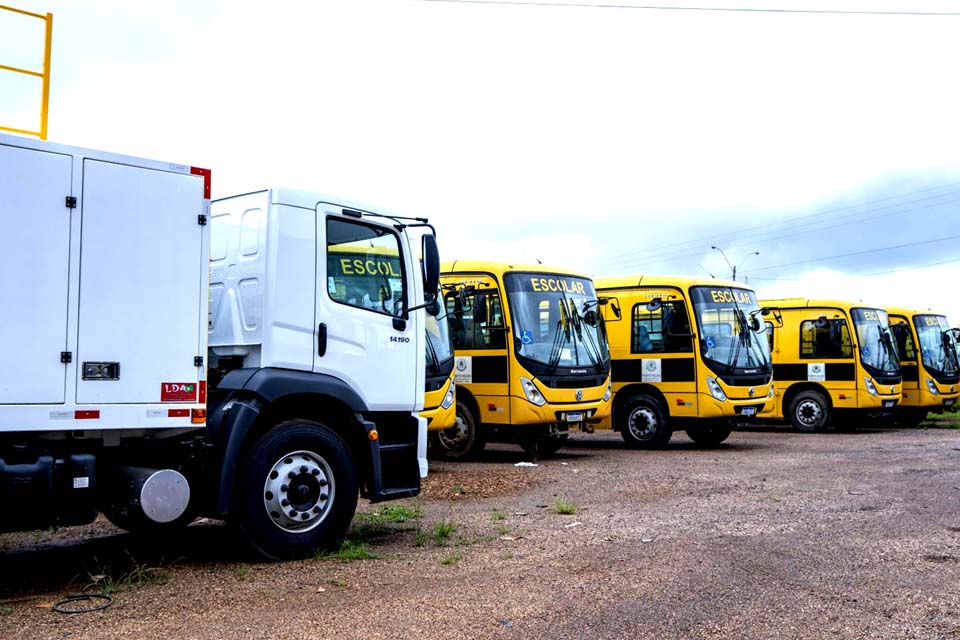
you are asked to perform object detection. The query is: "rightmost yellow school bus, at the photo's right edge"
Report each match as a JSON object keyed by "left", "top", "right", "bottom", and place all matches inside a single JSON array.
[{"left": 887, "top": 307, "right": 960, "bottom": 427}]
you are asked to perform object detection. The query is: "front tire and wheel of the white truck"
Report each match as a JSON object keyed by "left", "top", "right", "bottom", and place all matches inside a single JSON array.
[{"left": 232, "top": 420, "right": 359, "bottom": 560}]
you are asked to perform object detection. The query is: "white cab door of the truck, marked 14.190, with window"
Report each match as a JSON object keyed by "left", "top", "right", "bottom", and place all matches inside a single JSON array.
[{"left": 314, "top": 208, "right": 424, "bottom": 411}]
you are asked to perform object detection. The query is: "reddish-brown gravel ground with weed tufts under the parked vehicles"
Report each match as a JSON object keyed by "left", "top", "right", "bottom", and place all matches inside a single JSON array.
[{"left": 0, "top": 422, "right": 960, "bottom": 640}]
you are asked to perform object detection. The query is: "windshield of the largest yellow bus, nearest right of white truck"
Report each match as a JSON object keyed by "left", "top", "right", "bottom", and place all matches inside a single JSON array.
[{"left": 503, "top": 273, "right": 610, "bottom": 371}]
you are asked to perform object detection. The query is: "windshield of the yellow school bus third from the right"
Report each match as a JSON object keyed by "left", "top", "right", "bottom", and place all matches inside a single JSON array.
[{"left": 688, "top": 287, "right": 771, "bottom": 372}]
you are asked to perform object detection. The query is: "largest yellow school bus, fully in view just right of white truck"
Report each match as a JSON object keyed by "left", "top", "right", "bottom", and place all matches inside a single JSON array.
[{"left": 434, "top": 260, "right": 610, "bottom": 458}]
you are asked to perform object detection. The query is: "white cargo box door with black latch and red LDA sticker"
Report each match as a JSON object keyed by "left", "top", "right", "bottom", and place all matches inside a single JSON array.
[{"left": 77, "top": 159, "right": 208, "bottom": 403}]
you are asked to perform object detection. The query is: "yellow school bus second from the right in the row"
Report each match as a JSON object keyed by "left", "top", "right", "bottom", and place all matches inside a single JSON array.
[{"left": 760, "top": 298, "right": 902, "bottom": 432}]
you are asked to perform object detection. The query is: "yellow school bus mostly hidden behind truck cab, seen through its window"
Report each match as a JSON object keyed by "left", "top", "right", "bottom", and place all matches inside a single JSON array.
[{"left": 328, "top": 244, "right": 456, "bottom": 431}]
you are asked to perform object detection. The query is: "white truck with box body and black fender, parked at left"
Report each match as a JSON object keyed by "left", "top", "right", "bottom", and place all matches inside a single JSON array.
[{"left": 0, "top": 135, "right": 439, "bottom": 559}]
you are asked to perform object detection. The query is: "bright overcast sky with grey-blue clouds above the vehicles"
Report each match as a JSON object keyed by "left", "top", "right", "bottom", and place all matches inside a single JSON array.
[{"left": 0, "top": 0, "right": 960, "bottom": 325}]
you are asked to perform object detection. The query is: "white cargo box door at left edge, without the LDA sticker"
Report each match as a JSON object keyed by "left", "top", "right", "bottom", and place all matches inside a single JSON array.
[{"left": 0, "top": 145, "right": 76, "bottom": 404}]
